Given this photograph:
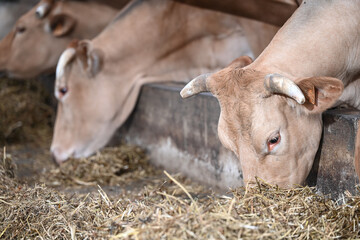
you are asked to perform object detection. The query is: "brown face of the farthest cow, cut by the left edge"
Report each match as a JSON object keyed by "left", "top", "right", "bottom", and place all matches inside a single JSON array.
[{"left": 0, "top": 0, "right": 76, "bottom": 78}]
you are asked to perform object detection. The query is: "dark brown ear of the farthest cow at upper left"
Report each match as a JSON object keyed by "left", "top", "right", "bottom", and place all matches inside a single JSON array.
[{"left": 50, "top": 13, "right": 76, "bottom": 37}]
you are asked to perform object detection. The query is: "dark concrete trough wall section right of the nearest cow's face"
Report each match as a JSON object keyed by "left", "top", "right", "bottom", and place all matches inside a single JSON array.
[{"left": 308, "top": 109, "right": 360, "bottom": 197}]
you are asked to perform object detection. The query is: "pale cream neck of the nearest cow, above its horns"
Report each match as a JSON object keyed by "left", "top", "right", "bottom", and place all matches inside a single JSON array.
[{"left": 250, "top": 0, "right": 360, "bottom": 84}]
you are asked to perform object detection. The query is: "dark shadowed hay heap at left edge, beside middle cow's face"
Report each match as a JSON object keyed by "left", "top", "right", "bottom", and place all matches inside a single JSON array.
[{"left": 0, "top": 79, "right": 54, "bottom": 146}]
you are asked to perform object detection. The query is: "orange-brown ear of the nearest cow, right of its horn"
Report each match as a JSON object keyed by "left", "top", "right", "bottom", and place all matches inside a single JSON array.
[{"left": 297, "top": 77, "right": 344, "bottom": 114}]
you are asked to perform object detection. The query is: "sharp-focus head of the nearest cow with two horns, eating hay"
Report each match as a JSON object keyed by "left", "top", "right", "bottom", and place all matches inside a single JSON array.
[{"left": 181, "top": 57, "right": 343, "bottom": 187}]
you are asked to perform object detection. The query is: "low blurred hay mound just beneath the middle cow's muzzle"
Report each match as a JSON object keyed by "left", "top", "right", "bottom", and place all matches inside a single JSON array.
[{"left": 40, "top": 144, "right": 158, "bottom": 187}]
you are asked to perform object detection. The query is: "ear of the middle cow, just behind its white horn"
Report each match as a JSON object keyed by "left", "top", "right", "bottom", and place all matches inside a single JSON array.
[{"left": 78, "top": 40, "right": 103, "bottom": 78}]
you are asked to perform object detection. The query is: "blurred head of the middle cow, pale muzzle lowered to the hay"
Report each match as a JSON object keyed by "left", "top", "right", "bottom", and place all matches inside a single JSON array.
[{"left": 51, "top": 40, "right": 140, "bottom": 163}]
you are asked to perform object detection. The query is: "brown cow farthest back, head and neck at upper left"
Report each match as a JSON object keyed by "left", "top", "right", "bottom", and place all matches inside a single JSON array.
[{"left": 0, "top": 0, "right": 118, "bottom": 79}]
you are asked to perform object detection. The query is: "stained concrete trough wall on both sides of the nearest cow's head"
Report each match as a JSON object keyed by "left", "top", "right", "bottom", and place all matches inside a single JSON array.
[{"left": 113, "top": 84, "right": 360, "bottom": 198}]
